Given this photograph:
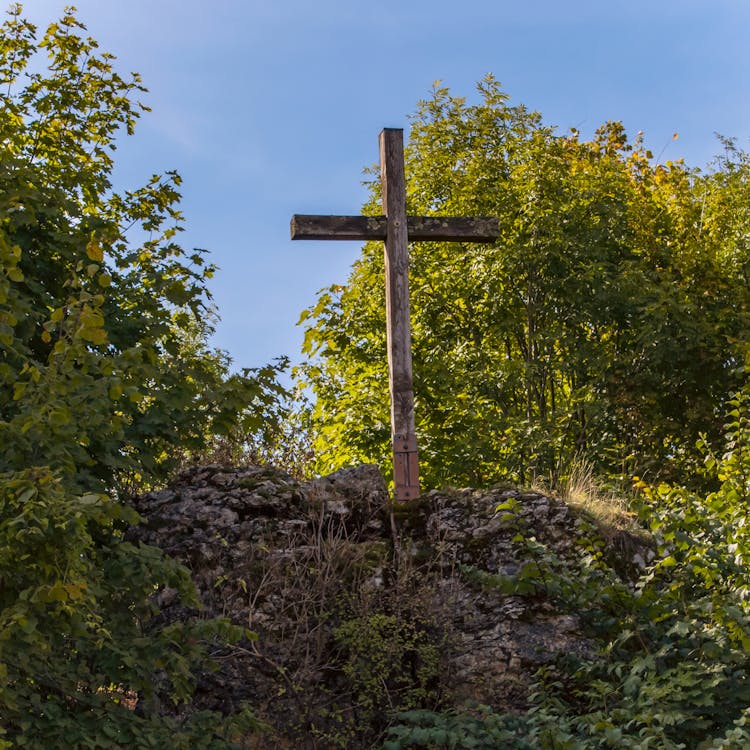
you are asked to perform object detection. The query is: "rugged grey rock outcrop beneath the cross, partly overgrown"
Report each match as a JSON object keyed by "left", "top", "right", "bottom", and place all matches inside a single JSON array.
[{"left": 126, "top": 466, "right": 644, "bottom": 748}]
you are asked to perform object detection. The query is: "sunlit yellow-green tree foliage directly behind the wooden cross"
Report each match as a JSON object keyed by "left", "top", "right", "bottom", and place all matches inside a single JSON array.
[{"left": 303, "top": 78, "right": 750, "bottom": 486}]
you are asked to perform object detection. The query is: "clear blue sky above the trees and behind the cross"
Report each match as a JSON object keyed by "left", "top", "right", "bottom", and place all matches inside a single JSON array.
[{"left": 20, "top": 0, "right": 750, "bottom": 368}]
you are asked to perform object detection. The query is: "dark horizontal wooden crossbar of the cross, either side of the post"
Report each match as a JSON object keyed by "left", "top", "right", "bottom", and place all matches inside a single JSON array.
[{"left": 290, "top": 214, "right": 500, "bottom": 242}]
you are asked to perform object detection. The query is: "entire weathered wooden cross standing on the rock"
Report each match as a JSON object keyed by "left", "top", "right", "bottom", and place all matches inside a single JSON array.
[{"left": 291, "top": 128, "right": 500, "bottom": 500}]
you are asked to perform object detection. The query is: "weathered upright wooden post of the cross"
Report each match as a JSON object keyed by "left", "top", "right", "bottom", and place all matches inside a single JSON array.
[{"left": 379, "top": 128, "right": 419, "bottom": 500}]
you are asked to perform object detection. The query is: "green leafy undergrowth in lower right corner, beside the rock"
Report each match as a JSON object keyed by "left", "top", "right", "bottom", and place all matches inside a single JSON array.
[{"left": 383, "top": 393, "right": 750, "bottom": 750}]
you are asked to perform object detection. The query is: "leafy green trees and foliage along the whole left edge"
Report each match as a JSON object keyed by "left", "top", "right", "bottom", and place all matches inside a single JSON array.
[{"left": 0, "top": 6, "right": 282, "bottom": 748}]
